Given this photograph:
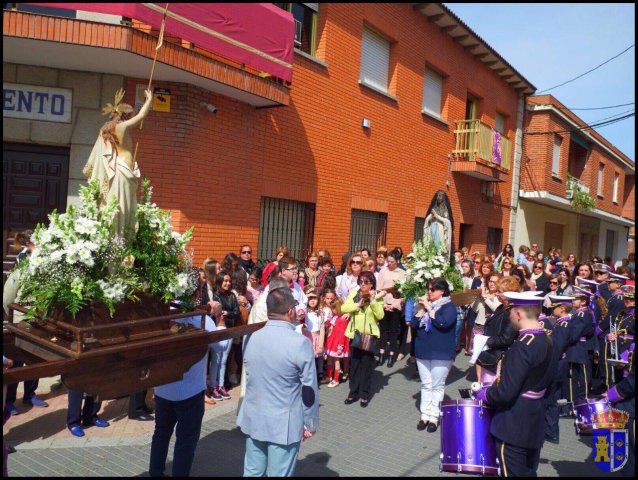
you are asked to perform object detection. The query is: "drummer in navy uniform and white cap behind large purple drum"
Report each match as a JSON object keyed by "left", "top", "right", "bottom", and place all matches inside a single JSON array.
[{"left": 476, "top": 292, "right": 555, "bottom": 476}]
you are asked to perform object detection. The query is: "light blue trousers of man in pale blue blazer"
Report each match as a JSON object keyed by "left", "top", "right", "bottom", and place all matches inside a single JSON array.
[{"left": 244, "top": 437, "right": 301, "bottom": 477}]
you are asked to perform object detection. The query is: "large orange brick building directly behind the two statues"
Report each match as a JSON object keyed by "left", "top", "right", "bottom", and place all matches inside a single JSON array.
[{"left": 3, "top": 3, "right": 535, "bottom": 262}]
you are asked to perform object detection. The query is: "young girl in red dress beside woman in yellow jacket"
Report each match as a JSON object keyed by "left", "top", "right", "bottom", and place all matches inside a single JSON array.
[{"left": 321, "top": 289, "right": 350, "bottom": 388}]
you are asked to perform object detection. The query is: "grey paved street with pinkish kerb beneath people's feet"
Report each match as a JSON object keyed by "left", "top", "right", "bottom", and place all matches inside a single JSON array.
[{"left": 4, "top": 354, "right": 606, "bottom": 477}]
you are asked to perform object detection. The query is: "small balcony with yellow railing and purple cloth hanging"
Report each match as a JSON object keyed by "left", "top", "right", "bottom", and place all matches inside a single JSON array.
[{"left": 452, "top": 120, "right": 512, "bottom": 182}]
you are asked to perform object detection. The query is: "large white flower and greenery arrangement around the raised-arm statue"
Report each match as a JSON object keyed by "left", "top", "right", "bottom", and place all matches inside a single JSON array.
[{"left": 16, "top": 179, "right": 197, "bottom": 318}]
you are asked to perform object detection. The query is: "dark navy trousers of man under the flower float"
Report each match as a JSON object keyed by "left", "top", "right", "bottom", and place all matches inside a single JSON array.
[{"left": 149, "top": 390, "right": 204, "bottom": 477}]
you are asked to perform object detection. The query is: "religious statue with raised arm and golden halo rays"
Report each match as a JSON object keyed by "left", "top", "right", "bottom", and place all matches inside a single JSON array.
[{"left": 82, "top": 89, "right": 153, "bottom": 239}]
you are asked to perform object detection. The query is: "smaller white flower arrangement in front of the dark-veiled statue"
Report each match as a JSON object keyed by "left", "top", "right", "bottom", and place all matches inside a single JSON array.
[{"left": 396, "top": 240, "right": 463, "bottom": 299}]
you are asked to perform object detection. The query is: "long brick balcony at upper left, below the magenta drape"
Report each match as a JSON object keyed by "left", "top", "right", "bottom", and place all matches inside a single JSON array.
[{"left": 2, "top": 10, "right": 290, "bottom": 107}]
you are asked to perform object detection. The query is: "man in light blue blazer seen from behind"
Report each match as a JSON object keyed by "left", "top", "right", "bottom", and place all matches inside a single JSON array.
[{"left": 237, "top": 288, "right": 319, "bottom": 477}]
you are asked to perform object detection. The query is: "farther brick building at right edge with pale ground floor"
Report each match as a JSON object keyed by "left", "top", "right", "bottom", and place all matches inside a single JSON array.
[{"left": 516, "top": 95, "right": 636, "bottom": 260}]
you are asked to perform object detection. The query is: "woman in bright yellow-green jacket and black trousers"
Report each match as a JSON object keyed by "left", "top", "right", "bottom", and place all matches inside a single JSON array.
[{"left": 341, "top": 272, "right": 384, "bottom": 407}]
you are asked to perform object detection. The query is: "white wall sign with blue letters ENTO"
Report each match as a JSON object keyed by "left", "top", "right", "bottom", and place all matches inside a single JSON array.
[{"left": 2, "top": 82, "right": 73, "bottom": 123}]
